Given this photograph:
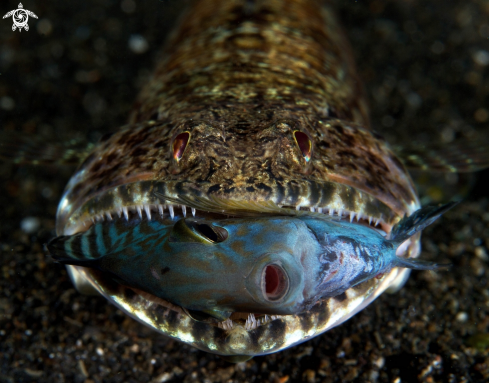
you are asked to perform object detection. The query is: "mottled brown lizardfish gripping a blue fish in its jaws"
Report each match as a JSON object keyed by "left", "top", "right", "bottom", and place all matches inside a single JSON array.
[{"left": 52, "top": 0, "right": 428, "bottom": 356}]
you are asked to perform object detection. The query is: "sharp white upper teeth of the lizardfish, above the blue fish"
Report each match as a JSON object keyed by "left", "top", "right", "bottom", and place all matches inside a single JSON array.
[{"left": 92, "top": 205, "right": 381, "bottom": 226}]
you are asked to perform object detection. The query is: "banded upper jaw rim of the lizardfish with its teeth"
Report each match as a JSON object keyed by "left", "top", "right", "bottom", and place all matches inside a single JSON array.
[{"left": 56, "top": 181, "right": 400, "bottom": 235}]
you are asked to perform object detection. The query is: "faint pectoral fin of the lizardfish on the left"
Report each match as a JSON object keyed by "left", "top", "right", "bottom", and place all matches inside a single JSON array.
[{"left": 0, "top": 132, "right": 93, "bottom": 166}]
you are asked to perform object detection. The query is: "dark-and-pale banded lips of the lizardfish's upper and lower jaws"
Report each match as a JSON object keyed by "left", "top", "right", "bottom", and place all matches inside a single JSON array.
[{"left": 58, "top": 181, "right": 411, "bottom": 355}]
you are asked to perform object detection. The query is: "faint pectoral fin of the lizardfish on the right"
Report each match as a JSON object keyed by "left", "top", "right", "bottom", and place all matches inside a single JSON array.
[{"left": 395, "top": 137, "right": 489, "bottom": 173}]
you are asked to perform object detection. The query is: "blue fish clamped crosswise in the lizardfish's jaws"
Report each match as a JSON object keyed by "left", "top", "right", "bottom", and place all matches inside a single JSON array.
[{"left": 48, "top": 202, "right": 456, "bottom": 320}]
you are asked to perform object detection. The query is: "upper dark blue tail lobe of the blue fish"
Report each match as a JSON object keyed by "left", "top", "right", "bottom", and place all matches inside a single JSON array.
[{"left": 389, "top": 201, "right": 459, "bottom": 244}]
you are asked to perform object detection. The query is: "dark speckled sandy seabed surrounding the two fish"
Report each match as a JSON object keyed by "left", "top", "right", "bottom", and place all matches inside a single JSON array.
[{"left": 0, "top": 0, "right": 489, "bottom": 382}]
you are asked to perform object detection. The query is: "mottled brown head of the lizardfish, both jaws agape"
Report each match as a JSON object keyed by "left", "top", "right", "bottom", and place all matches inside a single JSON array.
[{"left": 53, "top": 114, "right": 419, "bottom": 356}]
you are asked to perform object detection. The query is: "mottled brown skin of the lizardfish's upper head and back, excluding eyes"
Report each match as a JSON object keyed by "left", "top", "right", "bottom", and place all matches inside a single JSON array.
[{"left": 59, "top": 0, "right": 417, "bottom": 228}]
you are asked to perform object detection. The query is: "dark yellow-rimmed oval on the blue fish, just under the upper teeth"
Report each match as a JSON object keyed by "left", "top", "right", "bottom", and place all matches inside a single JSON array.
[{"left": 170, "top": 218, "right": 228, "bottom": 244}]
